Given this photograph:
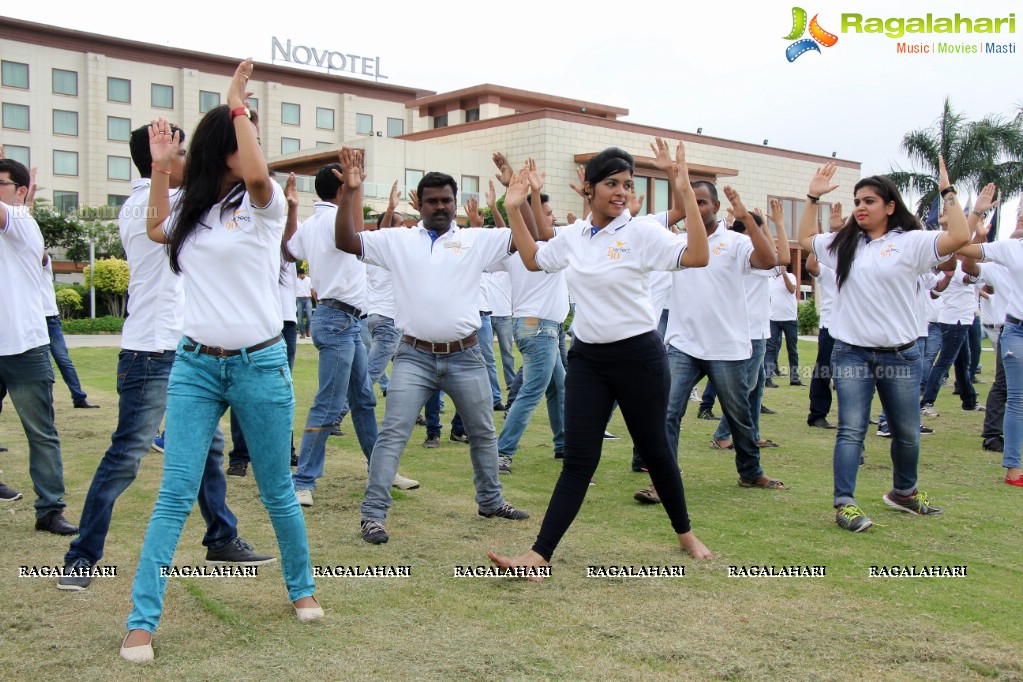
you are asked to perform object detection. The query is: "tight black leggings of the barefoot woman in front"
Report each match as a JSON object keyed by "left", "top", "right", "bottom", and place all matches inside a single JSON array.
[{"left": 533, "top": 331, "right": 691, "bottom": 561}]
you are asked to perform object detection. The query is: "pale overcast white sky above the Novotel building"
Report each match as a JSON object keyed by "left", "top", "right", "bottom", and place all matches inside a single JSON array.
[{"left": 3, "top": 0, "right": 1023, "bottom": 226}]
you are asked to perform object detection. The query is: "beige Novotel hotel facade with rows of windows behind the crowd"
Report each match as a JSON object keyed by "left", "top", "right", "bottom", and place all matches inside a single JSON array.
[{"left": 0, "top": 16, "right": 860, "bottom": 282}]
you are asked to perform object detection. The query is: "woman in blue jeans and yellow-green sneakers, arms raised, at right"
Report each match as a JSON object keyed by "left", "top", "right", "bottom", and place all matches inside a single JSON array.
[{"left": 799, "top": 158, "right": 970, "bottom": 533}]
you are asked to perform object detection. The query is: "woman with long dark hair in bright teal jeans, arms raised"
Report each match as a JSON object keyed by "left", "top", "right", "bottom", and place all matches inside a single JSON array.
[{"left": 121, "top": 59, "right": 315, "bottom": 663}]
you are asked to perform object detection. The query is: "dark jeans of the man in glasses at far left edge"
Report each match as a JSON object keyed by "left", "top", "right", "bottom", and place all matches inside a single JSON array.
[{"left": 0, "top": 347, "right": 64, "bottom": 518}]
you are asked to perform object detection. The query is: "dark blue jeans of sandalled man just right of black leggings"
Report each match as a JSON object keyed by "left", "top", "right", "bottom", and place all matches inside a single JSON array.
[{"left": 667, "top": 346, "right": 764, "bottom": 481}]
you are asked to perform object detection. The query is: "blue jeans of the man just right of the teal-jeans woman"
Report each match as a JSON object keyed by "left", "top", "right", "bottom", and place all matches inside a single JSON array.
[{"left": 294, "top": 304, "right": 378, "bottom": 490}]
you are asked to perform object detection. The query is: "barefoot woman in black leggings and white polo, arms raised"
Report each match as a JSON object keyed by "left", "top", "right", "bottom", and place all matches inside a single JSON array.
[{"left": 489, "top": 142, "right": 711, "bottom": 580}]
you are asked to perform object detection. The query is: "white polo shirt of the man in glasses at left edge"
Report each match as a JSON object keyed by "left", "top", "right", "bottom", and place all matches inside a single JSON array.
[{"left": 0, "top": 203, "right": 50, "bottom": 356}]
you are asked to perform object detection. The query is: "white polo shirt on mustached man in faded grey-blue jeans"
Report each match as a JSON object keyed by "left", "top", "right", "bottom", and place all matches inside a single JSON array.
[{"left": 358, "top": 221, "right": 512, "bottom": 344}]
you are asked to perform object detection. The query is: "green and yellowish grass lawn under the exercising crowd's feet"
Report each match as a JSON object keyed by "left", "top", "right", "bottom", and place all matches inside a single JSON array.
[{"left": 0, "top": 343, "right": 1023, "bottom": 681}]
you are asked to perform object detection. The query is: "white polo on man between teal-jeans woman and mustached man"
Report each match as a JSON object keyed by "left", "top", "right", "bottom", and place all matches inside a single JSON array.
[{"left": 287, "top": 201, "right": 366, "bottom": 309}]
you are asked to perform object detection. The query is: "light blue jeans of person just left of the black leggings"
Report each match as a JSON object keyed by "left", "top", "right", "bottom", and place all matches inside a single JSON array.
[{"left": 497, "top": 317, "right": 565, "bottom": 457}]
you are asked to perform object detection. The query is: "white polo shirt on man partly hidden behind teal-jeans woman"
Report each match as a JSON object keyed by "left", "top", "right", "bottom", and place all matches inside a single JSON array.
[{"left": 118, "top": 178, "right": 184, "bottom": 353}]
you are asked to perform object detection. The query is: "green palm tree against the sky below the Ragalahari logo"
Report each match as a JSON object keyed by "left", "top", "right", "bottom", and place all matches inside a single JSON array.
[{"left": 888, "top": 97, "right": 1023, "bottom": 218}]
